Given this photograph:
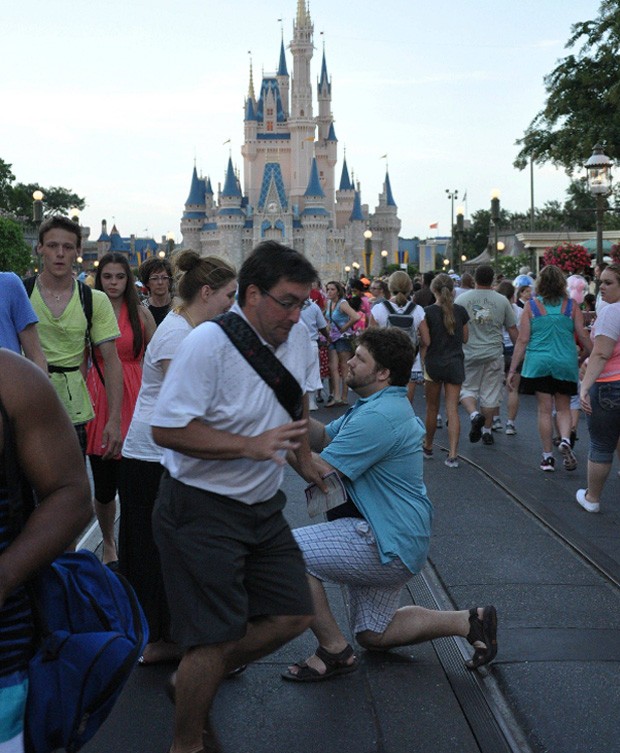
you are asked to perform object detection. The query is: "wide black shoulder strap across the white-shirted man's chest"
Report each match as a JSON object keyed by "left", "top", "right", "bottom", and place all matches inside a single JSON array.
[{"left": 213, "top": 311, "right": 303, "bottom": 421}]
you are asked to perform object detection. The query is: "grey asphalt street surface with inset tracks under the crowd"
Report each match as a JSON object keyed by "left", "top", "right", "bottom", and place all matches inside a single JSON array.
[{"left": 83, "top": 395, "right": 620, "bottom": 753}]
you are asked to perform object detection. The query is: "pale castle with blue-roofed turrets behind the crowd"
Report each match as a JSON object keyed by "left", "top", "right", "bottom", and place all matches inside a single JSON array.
[{"left": 181, "top": 0, "right": 401, "bottom": 280}]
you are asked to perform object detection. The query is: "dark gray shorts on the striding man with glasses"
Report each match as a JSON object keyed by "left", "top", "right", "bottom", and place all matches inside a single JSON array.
[{"left": 153, "top": 472, "right": 313, "bottom": 648}]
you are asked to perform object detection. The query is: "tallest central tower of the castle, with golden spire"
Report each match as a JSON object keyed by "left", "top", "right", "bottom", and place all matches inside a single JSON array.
[{"left": 288, "top": 0, "right": 315, "bottom": 205}]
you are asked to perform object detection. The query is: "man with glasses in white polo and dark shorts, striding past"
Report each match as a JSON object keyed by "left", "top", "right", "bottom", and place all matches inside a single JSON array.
[{"left": 152, "top": 241, "right": 325, "bottom": 753}]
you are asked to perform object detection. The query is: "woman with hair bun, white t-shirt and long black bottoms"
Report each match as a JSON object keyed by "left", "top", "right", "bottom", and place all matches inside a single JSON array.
[{"left": 119, "top": 250, "right": 237, "bottom": 664}]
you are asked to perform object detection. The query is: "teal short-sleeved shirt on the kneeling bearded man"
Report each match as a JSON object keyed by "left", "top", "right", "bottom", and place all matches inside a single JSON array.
[{"left": 321, "top": 387, "right": 433, "bottom": 573}]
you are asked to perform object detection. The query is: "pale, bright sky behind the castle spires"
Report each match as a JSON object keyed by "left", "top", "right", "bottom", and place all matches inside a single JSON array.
[{"left": 0, "top": 0, "right": 599, "bottom": 242}]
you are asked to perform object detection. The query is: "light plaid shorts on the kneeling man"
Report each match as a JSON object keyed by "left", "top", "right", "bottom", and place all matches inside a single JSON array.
[{"left": 293, "top": 518, "right": 412, "bottom": 635}]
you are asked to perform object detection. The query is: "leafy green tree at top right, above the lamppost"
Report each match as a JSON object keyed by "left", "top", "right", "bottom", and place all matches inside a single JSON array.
[{"left": 514, "top": 0, "right": 620, "bottom": 174}]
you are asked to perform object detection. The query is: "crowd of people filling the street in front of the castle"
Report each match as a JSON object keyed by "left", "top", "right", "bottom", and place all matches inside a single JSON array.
[{"left": 0, "top": 217, "right": 620, "bottom": 753}]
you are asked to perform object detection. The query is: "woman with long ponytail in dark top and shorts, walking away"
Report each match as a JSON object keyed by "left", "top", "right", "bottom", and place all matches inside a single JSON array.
[{"left": 420, "top": 273, "right": 469, "bottom": 468}]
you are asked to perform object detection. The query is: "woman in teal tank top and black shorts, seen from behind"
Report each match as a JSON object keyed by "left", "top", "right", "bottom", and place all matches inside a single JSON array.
[{"left": 507, "top": 265, "right": 591, "bottom": 472}]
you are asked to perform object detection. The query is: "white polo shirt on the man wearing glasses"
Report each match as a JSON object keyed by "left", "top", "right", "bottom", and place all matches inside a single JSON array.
[{"left": 151, "top": 305, "right": 316, "bottom": 504}]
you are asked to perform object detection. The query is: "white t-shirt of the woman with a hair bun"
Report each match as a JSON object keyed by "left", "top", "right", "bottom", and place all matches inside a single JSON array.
[{"left": 122, "top": 311, "right": 192, "bottom": 463}]
